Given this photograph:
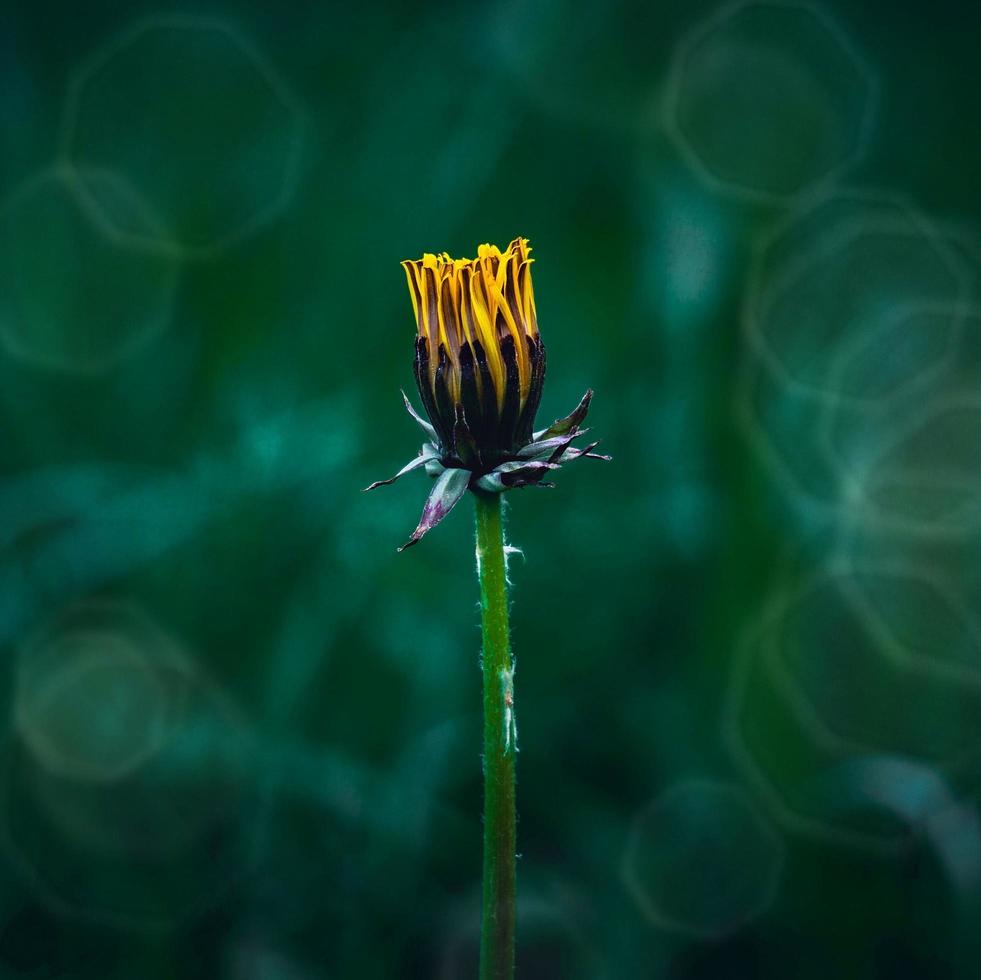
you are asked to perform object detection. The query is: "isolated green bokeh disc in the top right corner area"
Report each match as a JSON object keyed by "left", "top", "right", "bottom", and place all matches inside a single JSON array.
[{"left": 665, "top": 0, "right": 876, "bottom": 201}]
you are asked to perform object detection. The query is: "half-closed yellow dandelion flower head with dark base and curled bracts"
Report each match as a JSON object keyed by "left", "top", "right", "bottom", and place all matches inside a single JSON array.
[{"left": 366, "top": 238, "right": 609, "bottom": 550}]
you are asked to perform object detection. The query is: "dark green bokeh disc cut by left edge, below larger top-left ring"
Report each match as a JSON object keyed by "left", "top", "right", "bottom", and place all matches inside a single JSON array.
[{"left": 0, "top": 170, "right": 178, "bottom": 373}]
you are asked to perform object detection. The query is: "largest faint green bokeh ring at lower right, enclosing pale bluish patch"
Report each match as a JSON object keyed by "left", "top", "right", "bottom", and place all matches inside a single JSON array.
[{"left": 724, "top": 562, "right": 981, "bottom": 853}]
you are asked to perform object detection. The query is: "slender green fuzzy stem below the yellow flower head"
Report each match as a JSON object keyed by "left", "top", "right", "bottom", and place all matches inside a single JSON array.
[{"left": 475, "top": 494, "right": 517, "bottom": 980}]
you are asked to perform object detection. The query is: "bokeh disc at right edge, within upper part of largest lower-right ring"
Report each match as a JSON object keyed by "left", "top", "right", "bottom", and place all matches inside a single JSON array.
[{"left": 771, "top": 571, "right": 981, "bottom": 765}]
